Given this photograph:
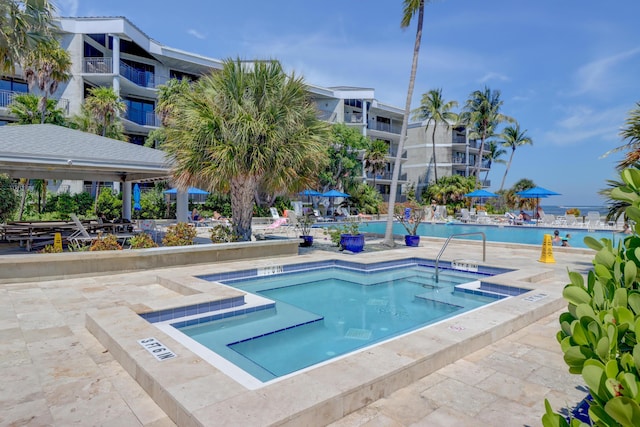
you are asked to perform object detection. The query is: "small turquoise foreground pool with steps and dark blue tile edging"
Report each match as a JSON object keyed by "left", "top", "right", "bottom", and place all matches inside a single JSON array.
[{"left": 143, "top": 258, "right": 527, "bottom": 382}]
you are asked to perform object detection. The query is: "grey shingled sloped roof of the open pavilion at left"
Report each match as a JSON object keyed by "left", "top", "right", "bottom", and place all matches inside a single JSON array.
[{"left": 0, "top": 124, "right": 170, "bottom": 181}]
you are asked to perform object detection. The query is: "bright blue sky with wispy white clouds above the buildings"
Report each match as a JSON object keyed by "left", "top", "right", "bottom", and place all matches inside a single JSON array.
[{"left": 54, "top": 0, "right": 640, "bottom": 206}]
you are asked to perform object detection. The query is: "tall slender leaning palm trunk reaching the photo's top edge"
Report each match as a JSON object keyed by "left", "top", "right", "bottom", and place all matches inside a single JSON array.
[{"left": 383, "top": 0, "right": 430, "bottom": 247}]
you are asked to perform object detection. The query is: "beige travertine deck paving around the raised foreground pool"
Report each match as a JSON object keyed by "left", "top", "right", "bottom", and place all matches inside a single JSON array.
[{"left": 0, "top": 240, "right": 593, "bottom": 426}]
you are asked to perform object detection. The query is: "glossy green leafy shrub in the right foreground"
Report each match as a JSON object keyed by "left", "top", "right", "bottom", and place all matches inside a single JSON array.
[{"left": 542, "top": 168, "right": 640, "bottom": 427}]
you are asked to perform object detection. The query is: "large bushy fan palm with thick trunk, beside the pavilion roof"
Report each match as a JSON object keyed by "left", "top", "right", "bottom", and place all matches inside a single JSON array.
[{"left": 164, "top": 59, "right": 328, "bottom": 241}]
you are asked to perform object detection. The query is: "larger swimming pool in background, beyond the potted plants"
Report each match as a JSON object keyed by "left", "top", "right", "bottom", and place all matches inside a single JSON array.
[{"left": 360, "top": 221, "right": 626, "bottom": 248}]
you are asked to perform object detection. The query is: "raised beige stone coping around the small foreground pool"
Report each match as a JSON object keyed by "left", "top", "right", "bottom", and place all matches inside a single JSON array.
[{"left": 85, "top": 253, "right": 565, "bottom": 426}]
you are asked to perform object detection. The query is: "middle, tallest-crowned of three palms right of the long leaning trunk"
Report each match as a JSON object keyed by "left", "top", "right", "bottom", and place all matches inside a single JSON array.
[{"left": 461, "top": 87, "right": 513, "bottom": 184}]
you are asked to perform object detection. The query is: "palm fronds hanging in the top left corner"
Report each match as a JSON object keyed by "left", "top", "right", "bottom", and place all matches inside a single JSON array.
[{"left": 0, "top": 0, "right": 55, "bottom": 73}]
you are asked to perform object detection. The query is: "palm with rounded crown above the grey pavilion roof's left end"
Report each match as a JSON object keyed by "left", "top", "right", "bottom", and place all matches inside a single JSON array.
[{"left": 24, "top": 39, "right": 71, "bottom": 123}]
